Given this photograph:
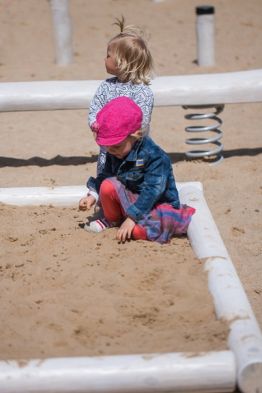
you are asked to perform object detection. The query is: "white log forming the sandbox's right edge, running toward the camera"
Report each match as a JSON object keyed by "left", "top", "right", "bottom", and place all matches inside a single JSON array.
[{"left": 180, "top": 185, "right": 262, "bottom": 393}]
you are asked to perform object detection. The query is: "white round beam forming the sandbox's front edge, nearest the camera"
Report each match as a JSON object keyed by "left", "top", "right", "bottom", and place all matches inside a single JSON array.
[{"left": 0, "top": 351, "right": 235, "bottom": 393}]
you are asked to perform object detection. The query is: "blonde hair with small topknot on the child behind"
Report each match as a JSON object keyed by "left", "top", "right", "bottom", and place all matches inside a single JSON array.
[{"left": 108, "top": 16, "right": 153, "bottom": 85}]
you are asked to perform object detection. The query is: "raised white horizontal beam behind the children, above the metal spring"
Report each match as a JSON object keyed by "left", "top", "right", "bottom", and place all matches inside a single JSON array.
[{"left": 0, "top": 69, "right": 262, "bottom": 112}]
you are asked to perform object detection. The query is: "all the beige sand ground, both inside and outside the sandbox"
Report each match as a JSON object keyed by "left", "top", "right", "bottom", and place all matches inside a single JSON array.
[{"left": 0, "top": 0, "right": 262, "bottom": 358}]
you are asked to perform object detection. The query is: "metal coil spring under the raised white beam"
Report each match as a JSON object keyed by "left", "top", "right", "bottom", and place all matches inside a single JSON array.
[{"left": 183, "top": 104, "right": 224, "bottom": 158}]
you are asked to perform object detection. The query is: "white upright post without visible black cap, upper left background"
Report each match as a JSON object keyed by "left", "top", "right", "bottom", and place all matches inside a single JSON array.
[{"left": 51, "top": 0, "right": 73, "bottom": 65}]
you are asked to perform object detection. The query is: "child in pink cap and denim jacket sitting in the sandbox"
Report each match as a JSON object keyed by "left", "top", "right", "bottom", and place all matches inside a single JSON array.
[{"left": 79, "top": 97, "right": 195, "bottom": 243}]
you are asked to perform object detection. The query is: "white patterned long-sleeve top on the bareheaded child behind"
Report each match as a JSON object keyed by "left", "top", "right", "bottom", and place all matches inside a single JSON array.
[{"left": 88, "top": 77, "right": 154, "bottom": 133}]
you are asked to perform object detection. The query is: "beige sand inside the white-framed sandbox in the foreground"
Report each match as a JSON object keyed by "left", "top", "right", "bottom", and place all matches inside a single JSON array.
[{"left": 0, "top": 207, "right": 227, "bottom": 358}]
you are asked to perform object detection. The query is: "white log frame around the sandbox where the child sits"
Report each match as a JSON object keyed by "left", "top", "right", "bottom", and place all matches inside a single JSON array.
[{"left": 0, "top": 182, "right": 262, "bottom": 393}]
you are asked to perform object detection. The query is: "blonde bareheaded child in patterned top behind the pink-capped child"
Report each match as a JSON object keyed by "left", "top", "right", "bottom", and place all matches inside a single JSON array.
[{"left": 88, "top": 18, "right": 154, "bottom": 174}]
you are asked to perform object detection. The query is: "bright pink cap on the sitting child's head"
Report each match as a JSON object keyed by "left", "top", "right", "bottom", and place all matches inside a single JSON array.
[{"left": 96, "top": 96, "right": 143, "bottom": 146}]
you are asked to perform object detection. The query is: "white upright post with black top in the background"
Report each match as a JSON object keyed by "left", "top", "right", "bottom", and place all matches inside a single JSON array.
[{"left": 196, "top": 5, "right": 215, "bottom": 66}]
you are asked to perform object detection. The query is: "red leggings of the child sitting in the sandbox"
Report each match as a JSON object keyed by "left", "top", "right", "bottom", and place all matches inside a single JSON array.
[{"left": 100, "top": 179, "right": 147, "bottom": 240}]
